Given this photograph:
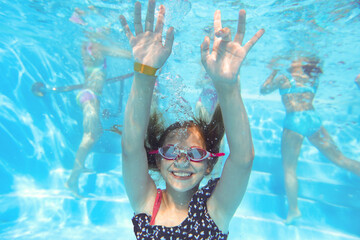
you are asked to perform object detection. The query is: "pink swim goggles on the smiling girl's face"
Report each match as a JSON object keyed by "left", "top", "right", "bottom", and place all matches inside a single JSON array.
[{"left": 149, "top": 144, "right": 225, "bottom": 162}]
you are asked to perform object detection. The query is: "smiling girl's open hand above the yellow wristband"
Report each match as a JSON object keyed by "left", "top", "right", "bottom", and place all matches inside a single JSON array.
[{"left": 120, "top": 0, "right": 174, "bottom": 68}]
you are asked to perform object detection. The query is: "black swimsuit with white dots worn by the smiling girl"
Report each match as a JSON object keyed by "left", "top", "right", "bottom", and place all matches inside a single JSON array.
[{"left": 132, "top": 178, "right": 228, "bottom": 240}]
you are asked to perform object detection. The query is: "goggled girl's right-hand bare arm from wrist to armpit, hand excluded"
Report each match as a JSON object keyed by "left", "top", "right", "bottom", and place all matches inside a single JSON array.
[{"left": 207, "top": 82, "right": 254, "bottom": 229}]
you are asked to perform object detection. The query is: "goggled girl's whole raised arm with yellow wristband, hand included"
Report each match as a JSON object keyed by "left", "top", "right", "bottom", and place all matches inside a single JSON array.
[{"left": 120, "top": 0, "right": 174, "bottom": 214}]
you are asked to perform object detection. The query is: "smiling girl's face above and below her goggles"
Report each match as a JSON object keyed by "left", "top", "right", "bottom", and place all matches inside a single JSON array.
[{"left": 157, "top": 127, "right": 208, "bottom": 192}]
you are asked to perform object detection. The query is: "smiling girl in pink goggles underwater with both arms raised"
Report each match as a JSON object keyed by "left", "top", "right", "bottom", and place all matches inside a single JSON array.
[{"left": 120, "top": 0, "right": 264, "bottom": 239}]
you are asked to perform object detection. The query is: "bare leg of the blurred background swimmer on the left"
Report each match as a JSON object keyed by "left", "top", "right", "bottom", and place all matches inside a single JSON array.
[{"left": 65, "top": 99, "right": 103, "bottom": 197}]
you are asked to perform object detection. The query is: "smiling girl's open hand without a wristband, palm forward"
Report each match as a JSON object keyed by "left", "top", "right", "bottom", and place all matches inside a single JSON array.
[{"left": 201, "top": 10, "right": 265, "bottom": 84}]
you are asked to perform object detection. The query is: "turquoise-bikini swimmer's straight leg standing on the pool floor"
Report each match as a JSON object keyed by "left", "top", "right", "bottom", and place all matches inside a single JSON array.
[{"left": 281, "top": 128, "right": 304, "bottom": 224}]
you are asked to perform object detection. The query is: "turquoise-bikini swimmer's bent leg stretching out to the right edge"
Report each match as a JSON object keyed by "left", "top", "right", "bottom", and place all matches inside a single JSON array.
[{"left": 308, "top": 127, "right": 360, "bottom": 176}]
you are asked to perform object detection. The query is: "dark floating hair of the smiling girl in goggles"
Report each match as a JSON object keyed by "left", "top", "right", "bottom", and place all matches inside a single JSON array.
[{"left": 144, "top": 104, "right": 225, "bottom": 173}]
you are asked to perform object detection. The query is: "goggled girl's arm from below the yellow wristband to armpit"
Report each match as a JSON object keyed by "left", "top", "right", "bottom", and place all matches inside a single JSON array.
[{"left": 121, "top": 72, "right": 156, "bottom": 213}]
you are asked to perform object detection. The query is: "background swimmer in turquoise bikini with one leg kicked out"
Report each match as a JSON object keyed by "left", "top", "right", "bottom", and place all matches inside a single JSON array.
[{"left": 260, "top": 58, "right": 360, "bottom": 223}]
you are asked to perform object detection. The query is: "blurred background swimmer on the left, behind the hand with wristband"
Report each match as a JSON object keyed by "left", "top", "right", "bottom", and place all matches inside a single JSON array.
[{"left": 65, "top": 7, "right": 132, "bottom": 197}]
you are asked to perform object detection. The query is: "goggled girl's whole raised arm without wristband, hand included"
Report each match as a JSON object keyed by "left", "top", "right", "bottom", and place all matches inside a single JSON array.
[{"left": 201, "top": 10, "right": 265, "bottom": 231}]
